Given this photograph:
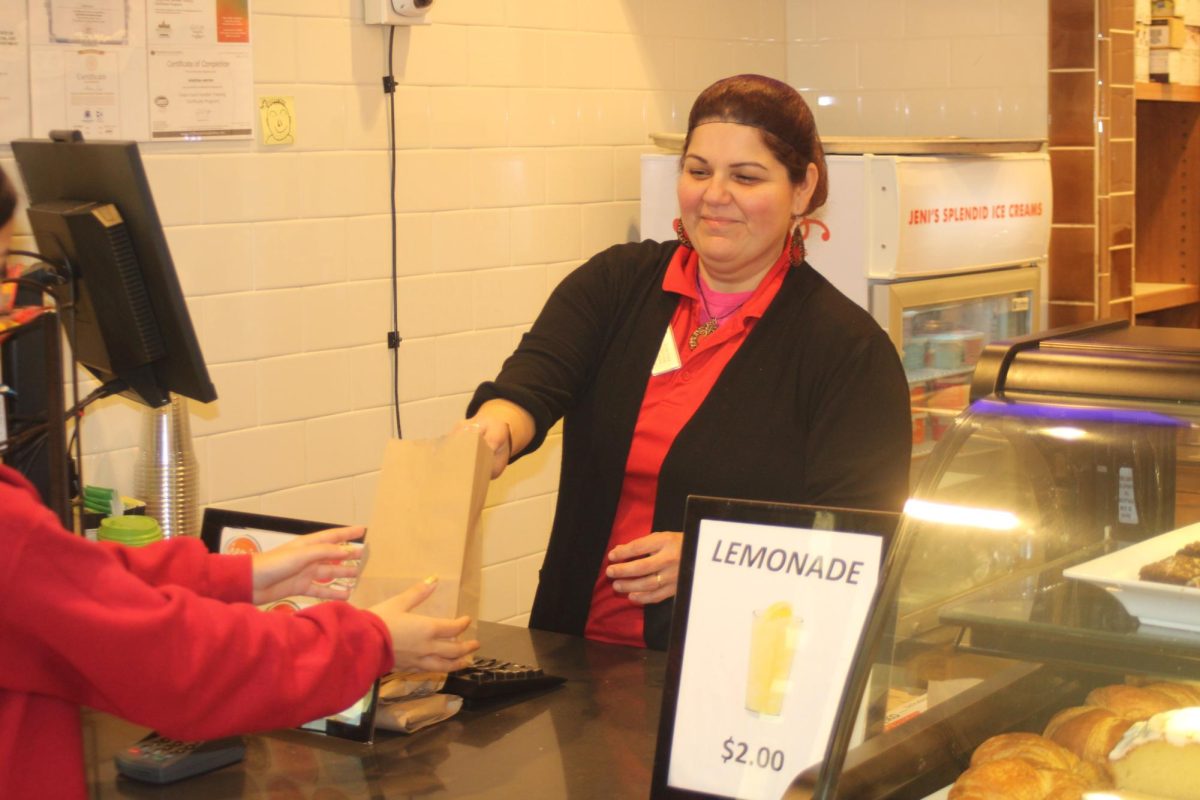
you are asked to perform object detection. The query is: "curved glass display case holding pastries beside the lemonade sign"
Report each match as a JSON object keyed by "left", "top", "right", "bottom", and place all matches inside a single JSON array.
[{"left": 790, "top": 321, "right": 1200, "bottom": 800}]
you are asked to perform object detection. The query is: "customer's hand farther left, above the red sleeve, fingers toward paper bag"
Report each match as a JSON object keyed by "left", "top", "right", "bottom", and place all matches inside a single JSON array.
[{"left": 251, "top": 525, "right": 366, "bottom": 604}]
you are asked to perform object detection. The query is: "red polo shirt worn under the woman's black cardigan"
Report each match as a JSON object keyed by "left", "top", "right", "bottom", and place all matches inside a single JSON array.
[{"left": 584, "top": 245, "right": 790, "bottom": 648}]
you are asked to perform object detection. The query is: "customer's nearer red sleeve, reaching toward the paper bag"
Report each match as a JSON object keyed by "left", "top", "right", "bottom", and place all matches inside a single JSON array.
[{"left": 0, "top": 467, "right": 392, "bottom": 739}]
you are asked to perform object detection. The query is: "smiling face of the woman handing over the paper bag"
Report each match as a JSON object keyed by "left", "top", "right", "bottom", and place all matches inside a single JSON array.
[{"left": 678, "top": 122, "right": 816, "bottom": 291}]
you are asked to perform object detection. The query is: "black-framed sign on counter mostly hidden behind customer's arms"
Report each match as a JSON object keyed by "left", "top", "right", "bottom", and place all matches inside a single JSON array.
[{"left": 200, "top": 509, "right": 379, "bottom": 742}]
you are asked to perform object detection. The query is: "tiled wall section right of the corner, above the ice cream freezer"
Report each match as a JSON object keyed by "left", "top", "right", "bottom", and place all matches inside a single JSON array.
[{"left": 786, "top": 0, "right": 1049, "bottom": 139}]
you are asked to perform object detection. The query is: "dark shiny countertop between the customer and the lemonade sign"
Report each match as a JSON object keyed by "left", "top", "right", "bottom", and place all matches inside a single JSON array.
[{"left": 84, "top": 622, "right": 666, "bottom": 800}]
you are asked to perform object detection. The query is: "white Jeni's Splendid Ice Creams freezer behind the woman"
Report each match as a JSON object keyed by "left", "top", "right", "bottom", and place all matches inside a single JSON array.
[{"left": 642, "top": 136, "right": 1051, "bottom": 460}]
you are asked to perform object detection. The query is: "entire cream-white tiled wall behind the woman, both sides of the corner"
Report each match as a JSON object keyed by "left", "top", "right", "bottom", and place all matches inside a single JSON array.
[{"left": 14, "top": 0, "right": 1048, "bottom": 624}]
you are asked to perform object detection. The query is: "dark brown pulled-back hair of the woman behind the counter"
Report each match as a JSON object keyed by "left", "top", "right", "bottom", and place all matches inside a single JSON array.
[{"left": 683, "top": 74, "right": 829, "bottom": 215}]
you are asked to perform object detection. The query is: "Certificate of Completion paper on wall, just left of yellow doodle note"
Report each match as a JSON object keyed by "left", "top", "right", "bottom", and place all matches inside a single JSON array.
[{"left": 149, "top": 47, "right": 257, "bottom": 140}]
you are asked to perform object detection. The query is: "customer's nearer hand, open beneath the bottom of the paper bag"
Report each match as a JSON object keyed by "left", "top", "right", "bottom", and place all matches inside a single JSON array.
[{"left": 367, "top": 578, "right": 479, "bottom": 672}]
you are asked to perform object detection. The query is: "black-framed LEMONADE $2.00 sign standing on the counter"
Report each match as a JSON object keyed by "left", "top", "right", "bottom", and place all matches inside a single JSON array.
[{"left": 650, "top": 497, "right": 900, "bottom": 800}]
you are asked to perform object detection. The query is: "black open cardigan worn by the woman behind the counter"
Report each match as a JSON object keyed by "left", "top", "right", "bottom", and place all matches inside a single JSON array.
[{"left": 467, "top": 241, "right": 912, "bottom": 649}]
